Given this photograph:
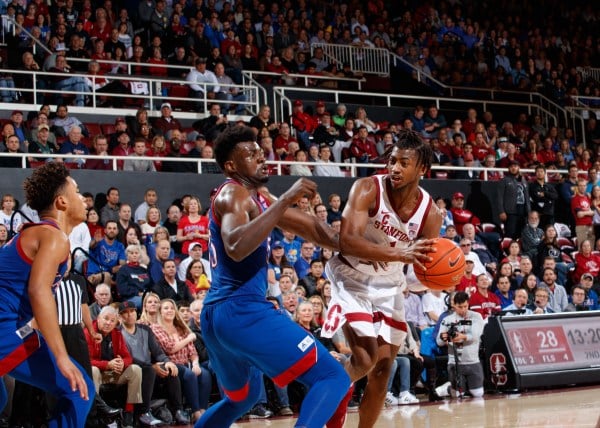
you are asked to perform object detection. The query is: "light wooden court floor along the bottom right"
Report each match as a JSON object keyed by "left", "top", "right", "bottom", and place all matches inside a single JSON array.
[{"left": 234, "top": 386, "right": 600, "bottom": 428}]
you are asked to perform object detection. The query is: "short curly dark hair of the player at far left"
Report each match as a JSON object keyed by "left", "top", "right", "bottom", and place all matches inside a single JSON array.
[{"left": 23, "top": 162, "right": 70, "bottom": 213}]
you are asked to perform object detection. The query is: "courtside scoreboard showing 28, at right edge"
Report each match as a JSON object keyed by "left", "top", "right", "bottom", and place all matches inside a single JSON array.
[{"left": 482, "top": 311, "right": 600, "bottom": 389}]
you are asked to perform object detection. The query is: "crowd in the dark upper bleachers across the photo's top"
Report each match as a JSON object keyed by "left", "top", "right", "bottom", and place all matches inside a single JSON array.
[{"left": 0, "top": 0, "right": 600, "bottom": 105}]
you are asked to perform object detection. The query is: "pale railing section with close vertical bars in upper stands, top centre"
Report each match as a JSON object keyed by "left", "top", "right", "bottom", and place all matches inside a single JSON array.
[{"left": 310, "top": 43, "right": 390, "bottom": 76}]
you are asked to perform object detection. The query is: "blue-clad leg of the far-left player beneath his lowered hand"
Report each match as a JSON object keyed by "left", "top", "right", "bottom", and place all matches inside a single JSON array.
[{"left": 9, "top": 340, "right": 95, "bottom": 428}]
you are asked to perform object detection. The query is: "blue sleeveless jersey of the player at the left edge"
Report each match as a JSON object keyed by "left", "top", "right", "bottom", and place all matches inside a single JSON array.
[{"left": 0, "top": 220, "right": 69, "bottom": 327}]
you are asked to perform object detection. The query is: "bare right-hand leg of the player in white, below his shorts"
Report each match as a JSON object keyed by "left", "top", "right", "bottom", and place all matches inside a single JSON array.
[{"left": 358, "top": 338, "right": 399, "bottom": 428}]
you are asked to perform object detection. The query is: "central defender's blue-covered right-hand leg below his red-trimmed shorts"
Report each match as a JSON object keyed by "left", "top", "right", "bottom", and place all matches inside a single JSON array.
[{"left": 296, "top": 342, "right": 350, "bottom": 428}]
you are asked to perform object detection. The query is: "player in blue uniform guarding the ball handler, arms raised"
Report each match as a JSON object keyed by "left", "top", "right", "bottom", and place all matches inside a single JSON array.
[{"left": 195, "top": 126, "right": 350, "bottom": 428}]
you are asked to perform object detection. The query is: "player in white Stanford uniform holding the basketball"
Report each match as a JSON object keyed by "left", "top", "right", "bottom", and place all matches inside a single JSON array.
[{"left": 322, "top": 130, "right": 442, "bottom": 428}]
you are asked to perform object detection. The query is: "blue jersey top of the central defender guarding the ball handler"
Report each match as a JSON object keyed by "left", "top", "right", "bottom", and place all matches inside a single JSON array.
[{"left": 204, "top": 180, "right": 269, "bottom": 304}]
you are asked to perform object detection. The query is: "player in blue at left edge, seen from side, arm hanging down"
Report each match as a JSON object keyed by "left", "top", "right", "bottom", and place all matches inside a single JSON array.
[{"left": 0, "top": 162, "right": 94, "bottom": 428}]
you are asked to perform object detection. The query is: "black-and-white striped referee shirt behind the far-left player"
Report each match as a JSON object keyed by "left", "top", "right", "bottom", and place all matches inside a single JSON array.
[{"left": 55, "top": 273, "right": 88, "bottom": 326}]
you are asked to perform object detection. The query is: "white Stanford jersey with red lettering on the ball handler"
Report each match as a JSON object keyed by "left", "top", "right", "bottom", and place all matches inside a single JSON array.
[{"left": 342, "top": 175, "right": 432, "bottom": 275}]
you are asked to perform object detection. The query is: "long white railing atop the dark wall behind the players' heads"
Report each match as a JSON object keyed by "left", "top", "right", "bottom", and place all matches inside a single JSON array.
[{"left": 0, "top": 152, "right": 572, "bottom": 181}]
